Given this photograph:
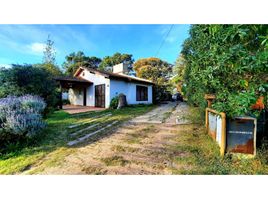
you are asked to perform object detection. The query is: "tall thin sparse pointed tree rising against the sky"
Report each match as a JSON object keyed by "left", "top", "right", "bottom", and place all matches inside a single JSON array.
[{"left": 40, "top": 35, "right": 62, "bottom": 76}]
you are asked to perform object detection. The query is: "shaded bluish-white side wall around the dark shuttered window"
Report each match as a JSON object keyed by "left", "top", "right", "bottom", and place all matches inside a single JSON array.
[{"left": 110, "top": 80, "right": 153, "bottom": 104}]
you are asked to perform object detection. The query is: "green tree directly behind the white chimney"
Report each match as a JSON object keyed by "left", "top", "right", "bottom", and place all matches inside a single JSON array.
[{"left": 99, "top": 52, "right": 134, "bottom": 71}]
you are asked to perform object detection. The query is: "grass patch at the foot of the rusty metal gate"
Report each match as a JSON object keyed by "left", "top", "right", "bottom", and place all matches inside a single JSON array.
[{"left": 171, "top": 128, "right": 268, "bottom": 174}]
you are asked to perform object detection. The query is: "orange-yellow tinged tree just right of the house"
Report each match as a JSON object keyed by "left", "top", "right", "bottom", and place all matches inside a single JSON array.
[{"left": 134, "top": 58, "right": 172, "bottom": 101}]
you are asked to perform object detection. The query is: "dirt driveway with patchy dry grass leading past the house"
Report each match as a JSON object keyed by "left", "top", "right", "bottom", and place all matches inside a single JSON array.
[{"left": 28, "top": 102, "right": 199, "bottom": 174}]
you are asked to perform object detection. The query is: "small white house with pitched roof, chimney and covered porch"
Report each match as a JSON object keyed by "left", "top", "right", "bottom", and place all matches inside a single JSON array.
[{"left": 57, "top": 63, "right": 153, "bottom": 108}]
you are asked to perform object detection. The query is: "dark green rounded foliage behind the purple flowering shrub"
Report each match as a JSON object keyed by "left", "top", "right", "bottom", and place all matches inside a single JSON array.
[{"left": 0, "top": 65, "right": 59, "bottom": 109}]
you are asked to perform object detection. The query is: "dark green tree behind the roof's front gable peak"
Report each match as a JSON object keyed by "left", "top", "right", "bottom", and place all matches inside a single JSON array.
[{"left": 63, "top": 51, "right": 102, "bottom": 76}]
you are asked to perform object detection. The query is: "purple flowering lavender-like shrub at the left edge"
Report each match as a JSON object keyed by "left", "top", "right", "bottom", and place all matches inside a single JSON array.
[{"left": 0, "top": 95, "right": 46, "bottom": 138}]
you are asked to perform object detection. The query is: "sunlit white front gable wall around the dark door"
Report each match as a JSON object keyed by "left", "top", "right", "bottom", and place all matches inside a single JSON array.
[{"left": 79, "top": 70, "right": 110, "bottom": 108}]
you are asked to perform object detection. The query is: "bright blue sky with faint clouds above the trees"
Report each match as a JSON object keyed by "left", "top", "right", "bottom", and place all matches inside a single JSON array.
[{"left": 0, "top": 24, "right": 190, "bottom": 66}]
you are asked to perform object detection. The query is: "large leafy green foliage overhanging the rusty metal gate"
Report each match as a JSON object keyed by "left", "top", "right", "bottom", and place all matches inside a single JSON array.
[{"left": 182, "top": 25, "right": 268, "bottom": 116}]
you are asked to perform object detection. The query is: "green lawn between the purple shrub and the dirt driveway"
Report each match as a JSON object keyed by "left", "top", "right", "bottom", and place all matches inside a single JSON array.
[{"left": 0, "top": 105, "right": 154, "bottom": 174}]
